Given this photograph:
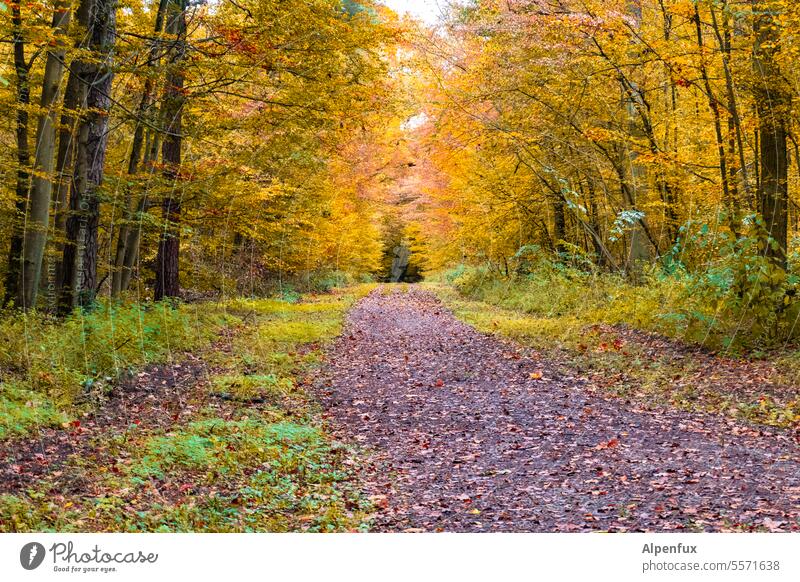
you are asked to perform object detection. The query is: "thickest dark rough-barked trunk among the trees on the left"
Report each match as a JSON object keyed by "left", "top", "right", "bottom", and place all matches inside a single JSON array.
[{"left": 60, "top": 0, "right": 117, "bottom": 312}]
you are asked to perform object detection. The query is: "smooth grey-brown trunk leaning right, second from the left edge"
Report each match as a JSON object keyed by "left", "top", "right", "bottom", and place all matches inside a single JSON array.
[{"left": 19, "top": 0, "right": 70, "bottom": 309}]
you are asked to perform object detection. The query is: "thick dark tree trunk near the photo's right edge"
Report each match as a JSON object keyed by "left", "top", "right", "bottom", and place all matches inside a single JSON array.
[{"left": 753, "top": 0, "right": 791, "bottom": 270}]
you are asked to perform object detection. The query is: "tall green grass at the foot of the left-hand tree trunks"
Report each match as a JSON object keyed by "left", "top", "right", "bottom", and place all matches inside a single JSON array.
[{"left": 0, "top": 302, "right": 237, "bottom": 422}]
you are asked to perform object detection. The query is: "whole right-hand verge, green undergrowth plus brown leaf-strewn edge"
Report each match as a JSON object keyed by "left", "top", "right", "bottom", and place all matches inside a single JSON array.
[{"left": 431, "top": 259, "right": 800, "bottom": 428}]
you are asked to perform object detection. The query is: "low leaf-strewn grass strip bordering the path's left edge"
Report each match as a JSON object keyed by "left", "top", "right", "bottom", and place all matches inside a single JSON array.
[{"left": 0, "top": 285, "right": 373, "bottom": 532}]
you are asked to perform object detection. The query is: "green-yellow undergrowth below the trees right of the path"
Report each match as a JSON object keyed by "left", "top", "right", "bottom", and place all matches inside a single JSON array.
[{"left": 444, "top": 234, "right": 800, "bottom": 349}]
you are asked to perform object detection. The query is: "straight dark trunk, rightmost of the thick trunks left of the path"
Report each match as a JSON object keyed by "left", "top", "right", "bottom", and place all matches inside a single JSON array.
[{"left": 154, "top": 0, "right": 187, "bottom": 300}]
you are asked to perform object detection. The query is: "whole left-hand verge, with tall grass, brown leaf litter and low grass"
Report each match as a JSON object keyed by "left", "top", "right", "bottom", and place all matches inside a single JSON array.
[{"left": 0, "top": 285, "right": 372, "bottom": 531}]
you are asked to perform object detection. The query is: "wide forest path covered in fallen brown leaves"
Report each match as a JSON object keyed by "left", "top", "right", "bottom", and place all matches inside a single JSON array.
[{"left": 321, "top": 287, "right": 800, "bottom": 531}]
